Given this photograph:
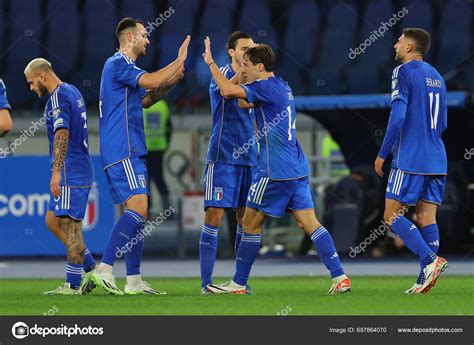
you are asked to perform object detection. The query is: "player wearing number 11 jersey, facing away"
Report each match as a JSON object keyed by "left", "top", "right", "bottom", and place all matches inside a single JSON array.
[{"left": 375, "top": 28, "right": 448, "bottom": 293}]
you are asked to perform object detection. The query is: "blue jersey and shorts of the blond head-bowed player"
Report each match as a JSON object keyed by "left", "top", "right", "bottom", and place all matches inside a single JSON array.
[{"left": 44, "top": 83, "right": 93, "bottom": 220}]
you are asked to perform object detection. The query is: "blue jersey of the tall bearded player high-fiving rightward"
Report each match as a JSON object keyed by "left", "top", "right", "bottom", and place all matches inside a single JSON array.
[{"left": 99, "top": 52, "right": 147, "bottom": 169}]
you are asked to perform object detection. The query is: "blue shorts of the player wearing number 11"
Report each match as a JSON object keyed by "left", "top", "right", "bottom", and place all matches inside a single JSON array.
[{"left": 385, "top": 168, "right": 446, "bottom": 206}]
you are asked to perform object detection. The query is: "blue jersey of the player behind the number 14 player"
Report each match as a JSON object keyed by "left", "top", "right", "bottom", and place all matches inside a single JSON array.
[{"left": 206, "top": 65, "right": 257, "bottom": 166}]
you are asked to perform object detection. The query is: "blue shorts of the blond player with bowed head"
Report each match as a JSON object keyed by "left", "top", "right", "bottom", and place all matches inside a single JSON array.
[{"left": 48, "top": 186, "right": 91, "bottom": 220}]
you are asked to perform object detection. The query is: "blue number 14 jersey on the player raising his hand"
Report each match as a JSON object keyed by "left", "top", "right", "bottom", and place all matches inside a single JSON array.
[{"left": 242, "top": 77, "right": 309, "bottom": 180}]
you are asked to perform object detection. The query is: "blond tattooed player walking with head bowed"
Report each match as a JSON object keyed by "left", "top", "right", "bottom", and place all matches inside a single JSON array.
[{"left": 25, "top": 58, "right": 95, "bottom": 295}]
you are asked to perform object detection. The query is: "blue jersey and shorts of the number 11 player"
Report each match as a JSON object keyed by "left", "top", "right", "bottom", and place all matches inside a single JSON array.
[{"left": 379, "top": 60, "right": 447, "bottom": 205}]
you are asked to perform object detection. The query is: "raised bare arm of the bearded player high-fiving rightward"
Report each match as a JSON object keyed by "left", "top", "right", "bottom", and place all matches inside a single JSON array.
[{"left": 138, "top": 35, "right": 191, "bottom": 89}]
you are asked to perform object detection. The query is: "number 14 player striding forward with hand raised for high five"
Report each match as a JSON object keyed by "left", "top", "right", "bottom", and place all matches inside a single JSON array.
[{"left": 203, "top": 37, "right": 351, "bottom": 294}]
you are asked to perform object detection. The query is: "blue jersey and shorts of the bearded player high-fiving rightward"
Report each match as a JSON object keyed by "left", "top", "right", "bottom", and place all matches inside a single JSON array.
[{"left": 99, "top": 52, "right": 148, "bottom": 204}]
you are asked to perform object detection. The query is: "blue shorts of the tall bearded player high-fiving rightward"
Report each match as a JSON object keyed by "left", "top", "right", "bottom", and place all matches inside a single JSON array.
[{"left": 105, "top": 157, "right": 148, "bottom": 205}]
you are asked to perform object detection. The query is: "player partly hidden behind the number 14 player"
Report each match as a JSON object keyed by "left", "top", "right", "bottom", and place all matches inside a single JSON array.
[{"left": 199, "top": 31, "right": 257, "bottom": 294}]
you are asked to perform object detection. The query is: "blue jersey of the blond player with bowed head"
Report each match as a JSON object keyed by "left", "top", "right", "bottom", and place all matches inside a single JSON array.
[{"left": 44, "top": 83, "right": 93, "bottom": 187}]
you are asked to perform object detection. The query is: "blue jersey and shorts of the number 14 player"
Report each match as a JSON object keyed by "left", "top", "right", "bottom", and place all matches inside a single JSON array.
[{"left": 243, "top": 77, "right": 314, "bottom": 217}]
